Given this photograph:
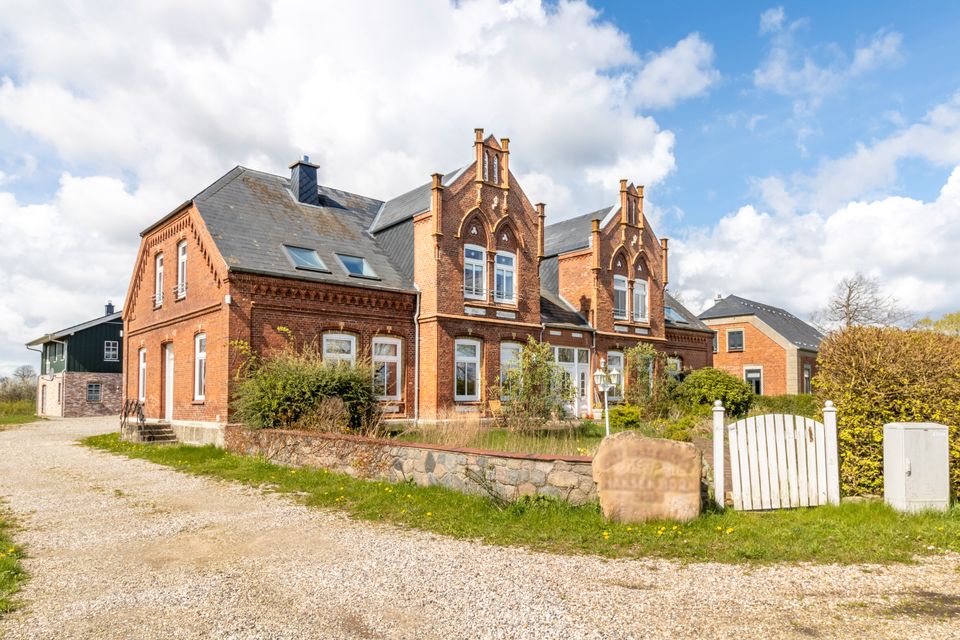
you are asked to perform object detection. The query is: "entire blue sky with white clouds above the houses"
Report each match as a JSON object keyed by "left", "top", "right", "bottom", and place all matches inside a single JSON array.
[{"left": 0, "top": 0, "right": 960, "bottom": 375}]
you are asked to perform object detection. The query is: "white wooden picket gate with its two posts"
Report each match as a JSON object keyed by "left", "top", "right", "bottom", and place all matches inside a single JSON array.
[{"left": 713, "top": 400, "right": 840, "bottom": 511}]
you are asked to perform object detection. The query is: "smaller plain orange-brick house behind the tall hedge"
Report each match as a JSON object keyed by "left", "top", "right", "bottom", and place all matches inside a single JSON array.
[{"left": 699, "top": 295, "right": 823, "bottom": 396}]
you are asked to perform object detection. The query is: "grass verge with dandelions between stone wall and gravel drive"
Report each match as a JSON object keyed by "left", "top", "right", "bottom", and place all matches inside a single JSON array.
[{"left": 83, "top": 434, "right": 960, "bottom": 563}]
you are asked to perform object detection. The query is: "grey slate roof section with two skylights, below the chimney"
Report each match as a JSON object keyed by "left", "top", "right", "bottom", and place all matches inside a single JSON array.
[{"left": 193, "top": 167, "right": 414, "bottom": 291}]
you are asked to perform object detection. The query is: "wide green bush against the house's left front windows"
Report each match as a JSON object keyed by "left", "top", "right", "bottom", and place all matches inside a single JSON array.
[{"left": 233, "top": 343, "right": 380, "bottom": 433}]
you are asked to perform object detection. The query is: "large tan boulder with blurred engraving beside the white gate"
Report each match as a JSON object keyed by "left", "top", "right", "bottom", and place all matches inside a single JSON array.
[{"left": 593, "top": 431, "right": 702, "bottom": 522}]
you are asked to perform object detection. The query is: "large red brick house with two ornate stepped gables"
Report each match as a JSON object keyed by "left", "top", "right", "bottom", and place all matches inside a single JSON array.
[{"left": 123, "top": 129, "right": 712, "bottom": 440}]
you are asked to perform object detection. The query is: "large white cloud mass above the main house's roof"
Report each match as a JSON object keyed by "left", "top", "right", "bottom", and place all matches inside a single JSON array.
[{"left": 0, "top": 0, "right": 717, "bottom": 376}]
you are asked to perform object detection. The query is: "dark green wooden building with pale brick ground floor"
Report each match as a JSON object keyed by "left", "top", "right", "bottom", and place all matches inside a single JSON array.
[{"left": 27, "top": 302, "right": 123, "bottom": 418}]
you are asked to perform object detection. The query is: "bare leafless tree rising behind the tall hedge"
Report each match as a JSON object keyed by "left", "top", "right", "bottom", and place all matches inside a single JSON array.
[{"left": 811, "top": 272, "right": 911, "bottom": 330}]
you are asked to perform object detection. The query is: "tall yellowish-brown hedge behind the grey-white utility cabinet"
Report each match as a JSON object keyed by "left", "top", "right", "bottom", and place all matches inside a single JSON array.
[{"left": 813, "top": 327, "right": 960, "bottom": 497}]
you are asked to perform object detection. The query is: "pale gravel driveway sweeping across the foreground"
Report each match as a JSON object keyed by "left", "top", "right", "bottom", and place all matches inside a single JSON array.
[{"left": 0, "top": 419, "right": 960, "bottom": 638}]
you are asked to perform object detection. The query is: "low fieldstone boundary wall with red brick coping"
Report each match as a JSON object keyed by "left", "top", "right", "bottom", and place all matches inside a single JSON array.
[{"left": 224, "top": 425, "right": 597, "bottom": 504}]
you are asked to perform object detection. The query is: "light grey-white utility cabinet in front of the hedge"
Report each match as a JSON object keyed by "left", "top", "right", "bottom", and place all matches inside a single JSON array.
[{"left": 883, "top": 422, "right": 950, "bottom": 512}]
